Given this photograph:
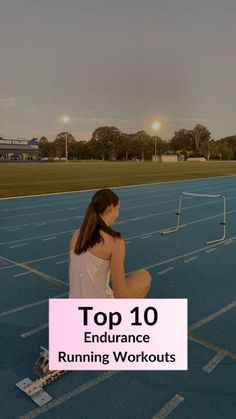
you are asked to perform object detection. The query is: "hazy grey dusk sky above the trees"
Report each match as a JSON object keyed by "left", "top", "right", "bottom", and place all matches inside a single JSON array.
[{"left": 0, "top": 0, "right": 236, "bottom": 140}]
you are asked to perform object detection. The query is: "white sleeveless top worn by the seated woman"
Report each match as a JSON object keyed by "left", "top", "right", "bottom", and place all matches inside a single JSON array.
[{"left": 69, "top": 249, "right": 114, "bottom": 298}]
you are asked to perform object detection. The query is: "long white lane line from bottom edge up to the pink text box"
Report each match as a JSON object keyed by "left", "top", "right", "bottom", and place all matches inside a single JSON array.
[{"left": 18, "top": 371, "right": 120, "bottom": 419}]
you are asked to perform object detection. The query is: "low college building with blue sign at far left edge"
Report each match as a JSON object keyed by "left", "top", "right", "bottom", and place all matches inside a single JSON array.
[{"left": 0, "top": 138, "right": 41, "bottom": 161}]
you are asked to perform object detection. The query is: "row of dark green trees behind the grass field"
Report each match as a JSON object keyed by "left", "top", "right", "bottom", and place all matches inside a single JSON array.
[{"left": 39, "top": 124, "right": 236, "bottom": 160}]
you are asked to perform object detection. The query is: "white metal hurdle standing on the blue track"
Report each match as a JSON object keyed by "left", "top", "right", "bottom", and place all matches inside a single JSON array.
[{"left": 161, "top": 192, "right": 226, "bottom": 244}]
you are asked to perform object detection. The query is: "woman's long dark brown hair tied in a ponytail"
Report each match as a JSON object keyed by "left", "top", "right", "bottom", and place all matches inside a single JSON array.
[{"left": 74, "top": 189, "right": 121, "bottom": 255}]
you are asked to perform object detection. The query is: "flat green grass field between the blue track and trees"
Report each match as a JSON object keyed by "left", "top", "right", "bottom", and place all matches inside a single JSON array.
[{"left": 0, "top": 161, "right": 236, "bottom": 198}]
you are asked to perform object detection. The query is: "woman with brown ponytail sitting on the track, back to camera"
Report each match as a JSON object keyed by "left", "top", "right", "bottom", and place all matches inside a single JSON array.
[{"left": 69, "top": 189, "right": 151, "bottom": 298}]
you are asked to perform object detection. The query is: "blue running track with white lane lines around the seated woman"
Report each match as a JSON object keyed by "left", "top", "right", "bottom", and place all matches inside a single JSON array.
[{"left": 0, "top": 176, "right": 236, "bottom": 419}]
